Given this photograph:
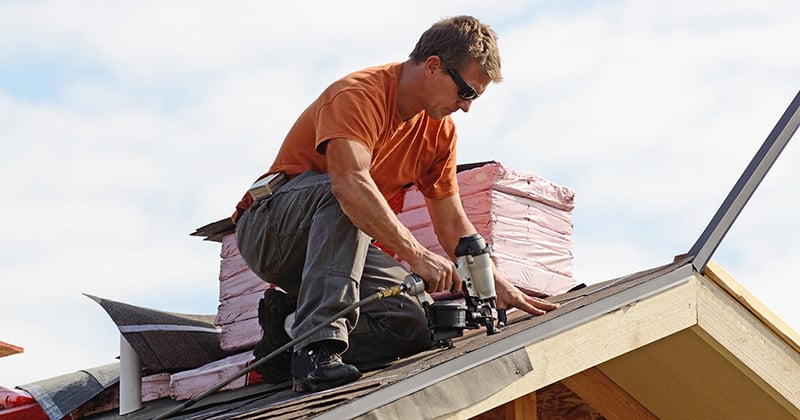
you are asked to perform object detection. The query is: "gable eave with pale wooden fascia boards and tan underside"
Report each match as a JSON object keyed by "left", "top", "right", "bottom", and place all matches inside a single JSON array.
[{"left": 320, "top": 264, "right": 800, "bottom": 419}]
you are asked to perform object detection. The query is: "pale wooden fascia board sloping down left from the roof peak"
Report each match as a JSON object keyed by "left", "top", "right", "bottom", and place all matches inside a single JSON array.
[{"left": 448, "top": 270, "right": 697, "bottom": 419}]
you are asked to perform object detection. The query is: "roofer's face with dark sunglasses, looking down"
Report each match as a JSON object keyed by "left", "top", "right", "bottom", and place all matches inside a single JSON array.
[{"left": 426, "top": 58, "right": 491, "bottom": 120}]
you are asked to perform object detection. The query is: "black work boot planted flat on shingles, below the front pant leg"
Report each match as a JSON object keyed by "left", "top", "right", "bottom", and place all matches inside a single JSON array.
[{"left": 292, "top": 341, "right": 361, "bottom": 392}]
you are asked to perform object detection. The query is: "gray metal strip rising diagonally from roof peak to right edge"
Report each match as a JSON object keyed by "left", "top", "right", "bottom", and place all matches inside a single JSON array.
[{"left": 689, "top": 92, "right": 800, "bottom": 273}]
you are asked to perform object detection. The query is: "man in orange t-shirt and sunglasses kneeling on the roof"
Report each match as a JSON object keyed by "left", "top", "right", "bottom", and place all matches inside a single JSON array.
[{"left": 233, "top": 16, "right": 556, "bottom": 392}]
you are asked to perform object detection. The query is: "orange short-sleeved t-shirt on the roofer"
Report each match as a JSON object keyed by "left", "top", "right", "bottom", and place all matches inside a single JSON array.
[{"left": 233, "top": 63, "right": 458, "bottom": 221}]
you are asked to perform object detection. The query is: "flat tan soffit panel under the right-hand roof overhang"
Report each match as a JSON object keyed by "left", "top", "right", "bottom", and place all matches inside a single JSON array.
[{"left": 598, "top": 327, "right": 800, "bottom": 420}]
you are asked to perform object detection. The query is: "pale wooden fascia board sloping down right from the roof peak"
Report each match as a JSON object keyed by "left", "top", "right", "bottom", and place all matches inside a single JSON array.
[{"left": 697, "top": 271, "right": 800, "bottom": 418}]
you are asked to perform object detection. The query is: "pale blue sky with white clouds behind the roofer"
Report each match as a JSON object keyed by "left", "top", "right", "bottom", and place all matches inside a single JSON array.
[{"left": 0, "top": 0, "right": 800, "bottom": 387}]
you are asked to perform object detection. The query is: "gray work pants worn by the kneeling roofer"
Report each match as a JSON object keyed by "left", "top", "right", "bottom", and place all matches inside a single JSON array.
[{"left": 236, "top": 172, "right": 432, "bottom": 364}]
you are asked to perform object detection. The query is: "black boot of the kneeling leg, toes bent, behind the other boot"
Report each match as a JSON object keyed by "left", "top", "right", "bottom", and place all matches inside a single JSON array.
[{"left": 253, "top": 288, "right": 297, "bottom": 384}]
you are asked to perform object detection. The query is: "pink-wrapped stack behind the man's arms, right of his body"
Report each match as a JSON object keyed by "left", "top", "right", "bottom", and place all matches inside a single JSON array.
[{"left": 398, "top": 163, "right": 576, "bottom": 295}]
